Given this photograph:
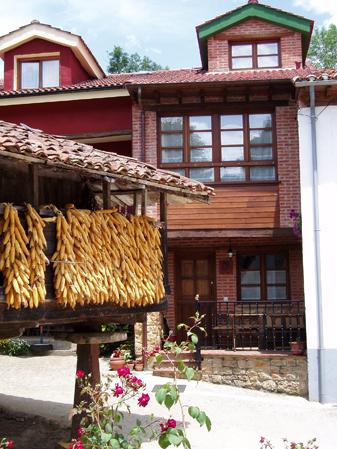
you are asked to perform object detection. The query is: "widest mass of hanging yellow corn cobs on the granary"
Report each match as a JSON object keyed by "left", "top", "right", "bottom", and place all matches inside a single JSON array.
[{"left": 52, "top": 207, "right": 164, "bottom": 307}]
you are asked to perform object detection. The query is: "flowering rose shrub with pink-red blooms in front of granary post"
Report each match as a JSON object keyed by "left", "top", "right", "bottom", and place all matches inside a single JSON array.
[{"left": 69, "top": 316, "right": 211, "bottom": 449}]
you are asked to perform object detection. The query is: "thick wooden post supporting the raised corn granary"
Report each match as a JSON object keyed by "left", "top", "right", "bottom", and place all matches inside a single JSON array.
[{"left": 71, "top": 343, "right": 100, "bottom": 438}]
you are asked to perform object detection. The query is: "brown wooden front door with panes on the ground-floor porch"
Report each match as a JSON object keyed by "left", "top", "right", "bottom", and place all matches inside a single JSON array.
[{"left": 176, "top": 253, "right": 216, "bottom": 346}]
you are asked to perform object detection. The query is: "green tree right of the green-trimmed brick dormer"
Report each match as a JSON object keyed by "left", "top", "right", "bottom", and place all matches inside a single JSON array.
[{"left": 308, "top": 24, "right": 337, "bottom": 68}]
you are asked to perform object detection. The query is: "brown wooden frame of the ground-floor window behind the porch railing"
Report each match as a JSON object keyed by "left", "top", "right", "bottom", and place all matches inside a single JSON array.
[{"left": 236, "top": 250, "right": 291, "bottom": 304}]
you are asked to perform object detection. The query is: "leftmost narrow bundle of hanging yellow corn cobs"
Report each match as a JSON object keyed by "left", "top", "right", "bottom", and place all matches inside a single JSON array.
[{"left": 0, "top": 204, "right": 31, "bottom": 309}]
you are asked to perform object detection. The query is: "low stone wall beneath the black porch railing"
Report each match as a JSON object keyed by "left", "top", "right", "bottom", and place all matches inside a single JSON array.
[{"left": 202, "top": 351, "right": 308, "bottom": 396}]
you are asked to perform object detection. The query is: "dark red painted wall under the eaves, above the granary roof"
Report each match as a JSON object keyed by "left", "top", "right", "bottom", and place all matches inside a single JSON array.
[{"left": 0, "top": 97, "right": 132, "bottom": 134}]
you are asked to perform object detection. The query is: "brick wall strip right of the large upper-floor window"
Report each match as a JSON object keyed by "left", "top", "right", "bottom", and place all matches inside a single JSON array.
[{"left": 276, "top": 104, "right": 301, "bottom": 227}]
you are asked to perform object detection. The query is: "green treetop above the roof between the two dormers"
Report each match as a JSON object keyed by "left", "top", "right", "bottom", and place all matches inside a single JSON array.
[{"left": 108, "top": 45, "right": 168, "bottom": 73}]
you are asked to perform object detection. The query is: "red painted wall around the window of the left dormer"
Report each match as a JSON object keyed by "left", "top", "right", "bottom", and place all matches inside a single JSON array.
[{"left": 4, "top": 39, "right": 90, "bottom": 90}]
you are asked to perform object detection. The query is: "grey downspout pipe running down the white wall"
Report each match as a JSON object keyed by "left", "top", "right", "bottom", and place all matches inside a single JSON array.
[{"left": 309, "top": 81, "right": 324, "bottom": 402}]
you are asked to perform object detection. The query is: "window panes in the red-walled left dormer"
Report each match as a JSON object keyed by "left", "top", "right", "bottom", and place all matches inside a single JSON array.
[{"left": 19, "top": 59, "right": 60, "bottom": 89}]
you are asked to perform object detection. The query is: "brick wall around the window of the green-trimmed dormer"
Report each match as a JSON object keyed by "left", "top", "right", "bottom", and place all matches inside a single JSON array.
[{"left": 208, "top": 19, "right": 302, "bottom": 72}]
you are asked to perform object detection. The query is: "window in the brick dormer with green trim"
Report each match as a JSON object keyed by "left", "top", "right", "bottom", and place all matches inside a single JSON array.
[{"left": 230, "top": 42, "right": 280, "bottom": 70}]
